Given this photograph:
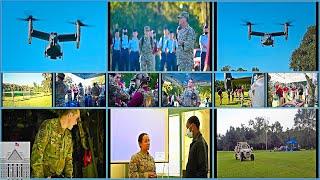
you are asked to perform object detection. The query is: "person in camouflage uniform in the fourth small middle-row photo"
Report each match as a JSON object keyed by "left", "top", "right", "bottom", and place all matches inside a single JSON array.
[{"left": 177, "top": 79, "right": 200, "bottom": 107}]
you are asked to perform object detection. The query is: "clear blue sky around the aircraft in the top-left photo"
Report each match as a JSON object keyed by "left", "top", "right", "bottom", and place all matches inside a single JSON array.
[{"left": 2, "top": 1, "right": 107, "bottom": 72}]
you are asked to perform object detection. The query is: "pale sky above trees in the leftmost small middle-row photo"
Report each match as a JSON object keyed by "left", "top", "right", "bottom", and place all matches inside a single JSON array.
[{"left": 3, "top": 73, "right": 44, "bottom": 86}]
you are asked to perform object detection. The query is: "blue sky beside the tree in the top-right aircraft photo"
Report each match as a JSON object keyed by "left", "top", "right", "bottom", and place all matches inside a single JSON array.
[{"left": 217, "top": 3, "right": 315, "bottom": 72}]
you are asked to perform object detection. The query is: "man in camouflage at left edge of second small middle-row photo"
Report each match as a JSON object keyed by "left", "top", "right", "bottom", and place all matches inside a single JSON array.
[{"left": 55, "top": 73, "right": 68, "bottom": 107}]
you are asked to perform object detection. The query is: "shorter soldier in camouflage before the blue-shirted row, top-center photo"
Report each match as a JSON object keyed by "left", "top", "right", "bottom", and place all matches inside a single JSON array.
[{"left": 140, "top": 26, "right": 155, "bottom": 71}]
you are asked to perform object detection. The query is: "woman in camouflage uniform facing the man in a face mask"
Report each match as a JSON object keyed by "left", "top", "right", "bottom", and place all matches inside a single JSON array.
[{"left": 128, "top": 133, "right": 157, "bottom": 178}]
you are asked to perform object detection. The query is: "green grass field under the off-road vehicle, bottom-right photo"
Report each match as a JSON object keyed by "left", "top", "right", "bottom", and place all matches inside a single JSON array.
[{"left": 217, "top": 150, "right": 316, "bottom": 178}]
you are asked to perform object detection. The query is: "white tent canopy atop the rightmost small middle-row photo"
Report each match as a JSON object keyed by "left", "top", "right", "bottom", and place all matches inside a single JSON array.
[{"left": 269, "top": 73, "right": 317, "bottom": 83}]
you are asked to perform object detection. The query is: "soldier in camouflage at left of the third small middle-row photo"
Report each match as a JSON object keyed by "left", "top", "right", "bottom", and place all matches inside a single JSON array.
[{"left": 108, "top": 73, "right": 130, "bottom": 107}]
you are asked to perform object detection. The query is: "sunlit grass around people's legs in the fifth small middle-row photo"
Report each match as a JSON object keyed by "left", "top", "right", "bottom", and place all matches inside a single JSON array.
[{"left": 214, "top": 92, "right": 250, "bottom": 107}]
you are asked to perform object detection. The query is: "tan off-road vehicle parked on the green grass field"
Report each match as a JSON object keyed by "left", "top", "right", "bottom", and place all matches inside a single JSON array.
[{"left": 234, "top": 142, "right": 254, "bottom": 161}]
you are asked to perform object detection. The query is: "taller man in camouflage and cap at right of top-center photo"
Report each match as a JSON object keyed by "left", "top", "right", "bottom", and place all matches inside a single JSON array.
[{"left": 176, "top": 11, "right": 196, "bottom": 71}]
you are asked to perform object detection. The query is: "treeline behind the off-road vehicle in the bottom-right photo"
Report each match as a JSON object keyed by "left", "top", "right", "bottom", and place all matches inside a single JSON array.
[{"left": 217, "top": 109, "right": 317, "bottom": 151}]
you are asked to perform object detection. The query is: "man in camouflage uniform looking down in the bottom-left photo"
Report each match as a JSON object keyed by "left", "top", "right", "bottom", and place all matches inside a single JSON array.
[{"left": 31, "top": 109, "right": 80, "bottom": 178}]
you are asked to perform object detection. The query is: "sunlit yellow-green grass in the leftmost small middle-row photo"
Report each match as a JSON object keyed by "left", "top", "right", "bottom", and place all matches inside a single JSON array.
[{"left": 3, "top": 95, "right": 52, "bottom": 107}]
